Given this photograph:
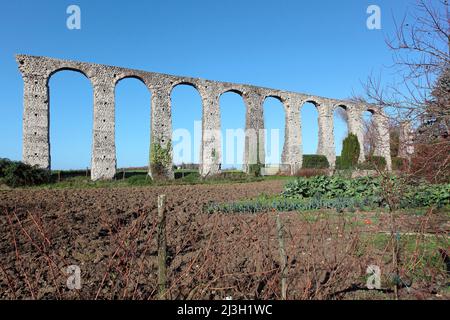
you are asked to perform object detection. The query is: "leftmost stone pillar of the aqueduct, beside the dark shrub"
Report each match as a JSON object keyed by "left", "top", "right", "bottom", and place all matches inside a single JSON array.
[{"left": 22, "top": 74, "right": 50, "bottom": 169}]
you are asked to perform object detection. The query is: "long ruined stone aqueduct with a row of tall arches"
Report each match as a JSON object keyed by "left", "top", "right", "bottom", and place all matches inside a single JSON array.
[{"left": 16, "top": 55, "right": 391, "bottom": 180}]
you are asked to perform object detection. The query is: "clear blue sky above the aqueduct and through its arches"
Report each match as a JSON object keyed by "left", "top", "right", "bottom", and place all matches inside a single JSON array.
[{"left": 0, "top": 0, "right": 415, "bottom": 169}]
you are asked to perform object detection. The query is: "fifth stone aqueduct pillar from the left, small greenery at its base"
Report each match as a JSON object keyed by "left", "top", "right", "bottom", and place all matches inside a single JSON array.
[{"left": 243, "top": 92, "right": 265, "bottom": 173}]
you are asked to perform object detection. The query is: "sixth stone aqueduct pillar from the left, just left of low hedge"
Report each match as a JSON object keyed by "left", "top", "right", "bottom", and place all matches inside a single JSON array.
[{"left": 281, "top": 98, "right": 303, "bottom": 175}]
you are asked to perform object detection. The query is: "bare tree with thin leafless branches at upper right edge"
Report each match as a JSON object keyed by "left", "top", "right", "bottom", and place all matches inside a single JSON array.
[{"left": 354, "top": 0, "right": 450, "bottom": 179}]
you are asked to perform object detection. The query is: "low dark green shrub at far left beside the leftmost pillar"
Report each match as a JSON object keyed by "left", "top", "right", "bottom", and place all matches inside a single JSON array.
[{"left": 2, "top": 161, "right": 51, "bottom": 188}]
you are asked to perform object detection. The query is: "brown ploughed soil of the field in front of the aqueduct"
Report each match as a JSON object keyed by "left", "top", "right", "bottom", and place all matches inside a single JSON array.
[{"left": 0, "top": 181, "right": 445, "bottom": 299}]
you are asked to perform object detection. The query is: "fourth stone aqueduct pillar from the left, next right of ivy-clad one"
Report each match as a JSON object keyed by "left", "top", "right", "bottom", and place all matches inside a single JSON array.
[{"left": 200, "top": 87, "right": 222, "bottom": 177}]
